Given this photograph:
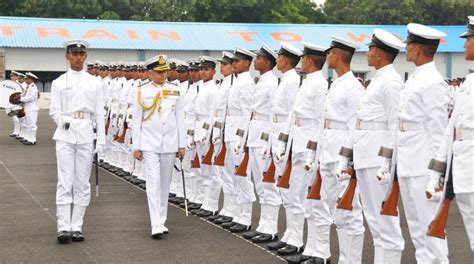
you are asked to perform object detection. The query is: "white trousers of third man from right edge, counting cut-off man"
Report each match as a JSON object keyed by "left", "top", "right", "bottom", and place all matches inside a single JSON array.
[{"left": 356, "top": 168, "right": 405, "bottom": 250}]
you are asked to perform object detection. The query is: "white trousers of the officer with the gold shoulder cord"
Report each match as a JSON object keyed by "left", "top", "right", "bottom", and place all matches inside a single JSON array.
[{"left": 143, "top": 151, "right": 176, "bottom": 228}]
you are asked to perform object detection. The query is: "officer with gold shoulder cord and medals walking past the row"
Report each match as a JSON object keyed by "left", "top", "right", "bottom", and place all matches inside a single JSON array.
[{"left": 132, "top": 55, "right": 186, "bottom": 239}]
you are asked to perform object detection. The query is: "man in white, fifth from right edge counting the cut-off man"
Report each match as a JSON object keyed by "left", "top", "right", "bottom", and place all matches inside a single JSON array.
[{"left": 286, "top": 42, "right": 330, "bottom": 263}]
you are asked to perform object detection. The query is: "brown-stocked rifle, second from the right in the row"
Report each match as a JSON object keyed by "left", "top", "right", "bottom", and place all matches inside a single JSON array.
[{"left": 378, "top": 147, "right": 400, "bottom": 216}]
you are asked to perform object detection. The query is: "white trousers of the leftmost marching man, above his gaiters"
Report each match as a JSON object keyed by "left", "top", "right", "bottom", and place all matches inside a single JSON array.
[{"left": 56, "top": 140, "right": 93, "bottom": 206}]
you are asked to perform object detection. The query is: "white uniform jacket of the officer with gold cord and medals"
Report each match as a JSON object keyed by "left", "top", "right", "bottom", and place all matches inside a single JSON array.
[{"left": 132, "top": 83, "right": 186, "bottom": 153}]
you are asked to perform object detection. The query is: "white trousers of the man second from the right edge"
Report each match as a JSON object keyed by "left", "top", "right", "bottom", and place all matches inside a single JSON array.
[{"left": 398, "top": 175, "right": 449, "bottom": 264}]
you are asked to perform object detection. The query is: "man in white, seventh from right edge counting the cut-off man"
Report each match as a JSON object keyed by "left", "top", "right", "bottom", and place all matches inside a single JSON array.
[{"left": 243, "top": 45, "right": 281, "bottom": 243}]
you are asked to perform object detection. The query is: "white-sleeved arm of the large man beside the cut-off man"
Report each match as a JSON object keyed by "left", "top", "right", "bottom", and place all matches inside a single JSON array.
[{"left": 423, "top": 82, "right": 449, "bottom": 153}]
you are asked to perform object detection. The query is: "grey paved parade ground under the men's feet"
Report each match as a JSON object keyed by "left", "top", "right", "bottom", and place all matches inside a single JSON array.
[{"left": 0, "top": 111, "right": 474, "bottom": 264}]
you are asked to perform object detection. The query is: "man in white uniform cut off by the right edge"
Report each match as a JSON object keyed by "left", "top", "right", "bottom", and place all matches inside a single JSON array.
[{"left": 426, "top": 16, "right": 474, "bottom": 252}]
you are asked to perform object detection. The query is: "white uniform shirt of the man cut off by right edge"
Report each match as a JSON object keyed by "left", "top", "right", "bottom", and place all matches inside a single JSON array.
[{"left": 436, "top": 73, "right": 474, "bottom": 193}]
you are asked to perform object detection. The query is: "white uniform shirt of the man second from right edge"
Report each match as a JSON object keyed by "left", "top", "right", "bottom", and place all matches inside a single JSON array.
[{"left": 397, "top": 62, "right": 449, "bottom": 177}]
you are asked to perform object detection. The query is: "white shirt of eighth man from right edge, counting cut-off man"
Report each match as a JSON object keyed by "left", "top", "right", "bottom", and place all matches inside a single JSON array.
[{"left": 225, "top": 71, "right": 255, "bottom": 142}]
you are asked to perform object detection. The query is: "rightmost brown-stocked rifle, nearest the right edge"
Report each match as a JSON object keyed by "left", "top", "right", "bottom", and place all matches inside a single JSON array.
[{"left": 426, "top": 160, "right": 455, "bottom": 239}]
